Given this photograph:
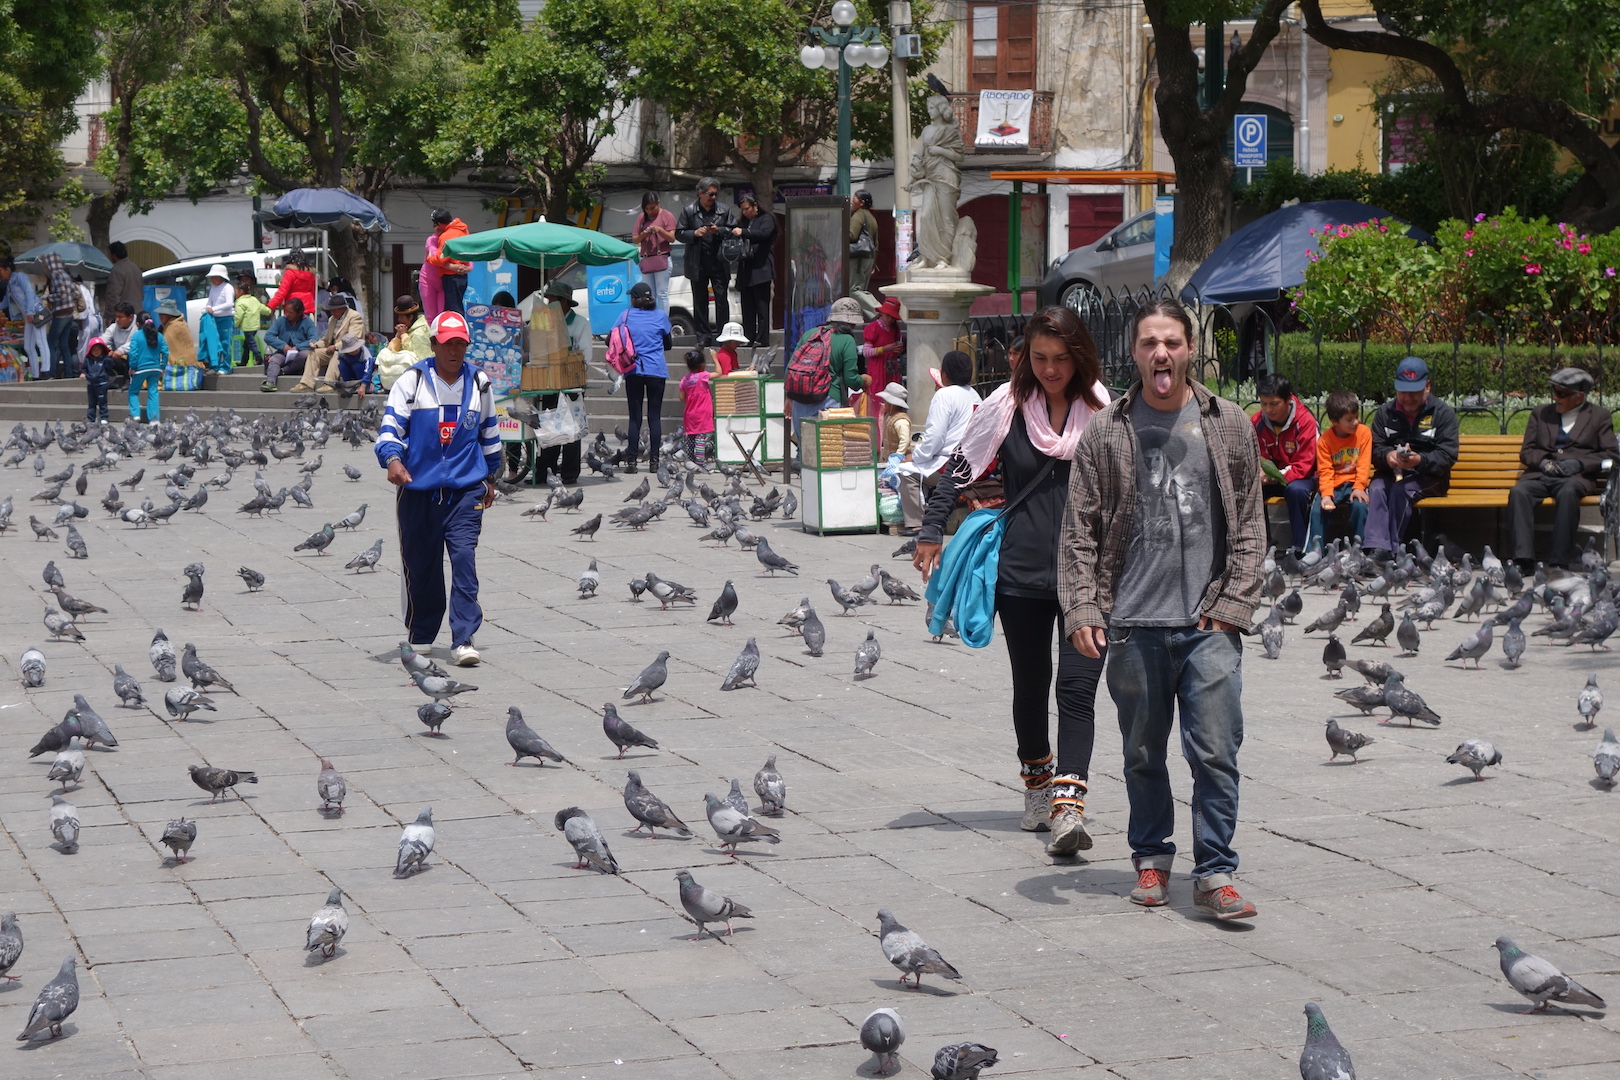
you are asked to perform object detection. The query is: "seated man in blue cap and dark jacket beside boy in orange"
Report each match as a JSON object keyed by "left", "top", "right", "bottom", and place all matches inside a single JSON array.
[{"left": 1362, "top": 356, "right": 1458, "bottom": 557}]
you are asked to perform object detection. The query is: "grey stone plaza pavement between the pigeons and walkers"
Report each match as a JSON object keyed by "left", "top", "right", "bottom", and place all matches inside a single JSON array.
[{"left": 0, "top": 442, "right": 1620, "bottom": 1080}]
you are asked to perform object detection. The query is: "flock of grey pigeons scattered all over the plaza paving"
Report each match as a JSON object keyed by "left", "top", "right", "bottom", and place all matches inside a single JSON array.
[{"left": 0, "top": 408, "right": 1620, "bottom": 1080}]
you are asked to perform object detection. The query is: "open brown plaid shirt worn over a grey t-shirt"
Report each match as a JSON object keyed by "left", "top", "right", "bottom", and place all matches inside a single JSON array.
[{"left": 1058, "top": 379, "right": 1265, "bottom": 633}]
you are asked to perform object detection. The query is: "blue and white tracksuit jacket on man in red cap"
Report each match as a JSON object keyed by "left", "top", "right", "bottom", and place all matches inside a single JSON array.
[{"left": 376, "top": 356, "right": 501, "bottom": 491}]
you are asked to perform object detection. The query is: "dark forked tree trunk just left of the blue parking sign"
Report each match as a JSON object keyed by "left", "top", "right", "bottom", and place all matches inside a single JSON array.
[{"left": 1144, "top": 0, "right": 1293, "bottom": 291}]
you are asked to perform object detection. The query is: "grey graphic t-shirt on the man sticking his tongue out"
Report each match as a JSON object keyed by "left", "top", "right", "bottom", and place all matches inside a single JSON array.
[{"left": 1110, "top": 397, "right": 1226, "bottom": 627}]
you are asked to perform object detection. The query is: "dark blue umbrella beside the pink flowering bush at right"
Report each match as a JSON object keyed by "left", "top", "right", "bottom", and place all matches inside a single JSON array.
[{"left": 1181, "top": 199, "right": 1434, "bottom": 304}]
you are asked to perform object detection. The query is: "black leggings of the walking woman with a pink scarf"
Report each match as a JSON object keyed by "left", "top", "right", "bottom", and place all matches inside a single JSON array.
[{"left": 996, "top": 593, "right": 1103, "bottom": 780}]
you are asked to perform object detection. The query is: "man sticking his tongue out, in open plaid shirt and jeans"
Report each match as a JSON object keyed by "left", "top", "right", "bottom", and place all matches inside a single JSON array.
[{"left": 1058, "top": 300, "right": 1265, "bottom": 920}]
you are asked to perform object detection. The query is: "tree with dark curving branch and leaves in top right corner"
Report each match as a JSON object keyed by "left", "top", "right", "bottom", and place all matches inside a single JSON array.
[{"left": 1299, "top": 0, "right": 1620, "bottom": 232}]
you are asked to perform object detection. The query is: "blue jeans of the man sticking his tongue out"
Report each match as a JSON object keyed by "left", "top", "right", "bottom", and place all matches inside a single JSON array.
[{"left": 1108, "top": 627, "right": 1243, "bottom": 889}]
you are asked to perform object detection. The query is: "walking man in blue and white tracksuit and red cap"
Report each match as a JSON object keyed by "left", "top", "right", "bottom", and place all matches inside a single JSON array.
[{"left": 376, "top": 311, "right": 501, "bottom": 667}]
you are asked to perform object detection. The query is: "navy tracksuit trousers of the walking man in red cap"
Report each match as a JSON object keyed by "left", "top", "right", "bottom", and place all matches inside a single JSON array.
[{"left": 394, "top": 484, "right": 484, "bottom": 646}]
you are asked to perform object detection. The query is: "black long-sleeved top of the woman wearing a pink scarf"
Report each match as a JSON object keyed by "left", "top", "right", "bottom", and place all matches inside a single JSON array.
[{"left": 917, "top": 410, "right": 1069, "bottom": 599}]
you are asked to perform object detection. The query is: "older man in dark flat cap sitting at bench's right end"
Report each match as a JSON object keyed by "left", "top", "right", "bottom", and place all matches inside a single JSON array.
[{"left": 1508, "top": 368, "right": 1615, "bottom": 570}]
